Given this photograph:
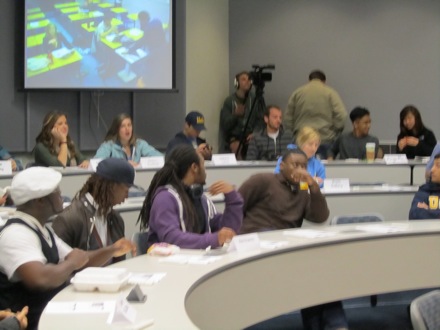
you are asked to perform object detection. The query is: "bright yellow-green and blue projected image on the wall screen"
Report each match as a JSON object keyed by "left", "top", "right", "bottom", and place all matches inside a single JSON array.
[{"left": 25, "top": 0, "right": 173, "bottom": 89}]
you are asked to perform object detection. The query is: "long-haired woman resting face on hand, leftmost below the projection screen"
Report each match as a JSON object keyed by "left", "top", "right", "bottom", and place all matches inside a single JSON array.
[{"left": 34, "top": 111, "right": 89, "bottom": 168}]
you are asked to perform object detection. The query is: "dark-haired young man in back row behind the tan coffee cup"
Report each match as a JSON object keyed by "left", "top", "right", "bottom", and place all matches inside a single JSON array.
[{"left": 328, "top": 107, "right": 383, "bottom": 160}]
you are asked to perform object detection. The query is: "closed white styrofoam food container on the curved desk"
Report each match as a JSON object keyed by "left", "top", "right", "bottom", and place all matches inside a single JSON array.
[{"left": 70, "top": 267, "right": 130, "bottom": 292}]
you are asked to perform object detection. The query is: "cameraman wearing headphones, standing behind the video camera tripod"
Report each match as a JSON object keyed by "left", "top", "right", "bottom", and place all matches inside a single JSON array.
[{"left": 219, "top": 71, "right": 264, "bottom": 159}]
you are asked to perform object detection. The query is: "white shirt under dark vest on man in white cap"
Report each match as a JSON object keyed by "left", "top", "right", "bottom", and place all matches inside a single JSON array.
[{"left": 0, "top": 211, "right": 72, "bottom": 282}]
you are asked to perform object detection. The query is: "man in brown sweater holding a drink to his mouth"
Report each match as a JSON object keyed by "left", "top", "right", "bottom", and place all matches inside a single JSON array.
[{"left": 238, "top": 149, "right": 348, "bottom": 329}]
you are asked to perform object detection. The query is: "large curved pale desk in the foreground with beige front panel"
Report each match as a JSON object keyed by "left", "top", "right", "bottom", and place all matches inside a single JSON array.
[{"left": 40, "top": 221, "right": 440, "bottom": 330}]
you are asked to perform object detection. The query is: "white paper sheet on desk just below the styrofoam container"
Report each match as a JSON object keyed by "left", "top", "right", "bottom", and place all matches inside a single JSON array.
[{"left": 44, "top": 300, "right": 116, "bottom": 314}]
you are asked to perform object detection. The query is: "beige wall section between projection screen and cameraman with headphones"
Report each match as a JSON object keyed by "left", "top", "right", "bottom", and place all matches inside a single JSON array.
[{"left": 185, "top": 0, "right": 230, "bottom": 152}]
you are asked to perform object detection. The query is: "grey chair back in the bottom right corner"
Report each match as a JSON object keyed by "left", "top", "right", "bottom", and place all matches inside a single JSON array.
[{"left": 410, "top": 290, "right": 440, "bottom": 330}]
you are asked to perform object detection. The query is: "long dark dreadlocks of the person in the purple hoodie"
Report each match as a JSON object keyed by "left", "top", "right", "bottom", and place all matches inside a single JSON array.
[{"left": 136, "top": 144, "right": 200, "bottom": 230}]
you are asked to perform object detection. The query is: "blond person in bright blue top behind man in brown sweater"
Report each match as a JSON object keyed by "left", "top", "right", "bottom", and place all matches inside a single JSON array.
[{"left": 275, "top": 126, "right": 326, "bottom": 186}]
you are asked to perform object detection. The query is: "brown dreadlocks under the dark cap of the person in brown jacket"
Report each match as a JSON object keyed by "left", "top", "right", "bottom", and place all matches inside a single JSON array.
[{"left": 77, "top": 173, "right": 118, "bottom": 217}]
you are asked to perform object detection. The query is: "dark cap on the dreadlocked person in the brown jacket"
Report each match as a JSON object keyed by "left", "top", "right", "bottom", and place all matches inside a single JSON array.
[{"left": 96, "top": 158, "right": 134, "bottom": 186}]
